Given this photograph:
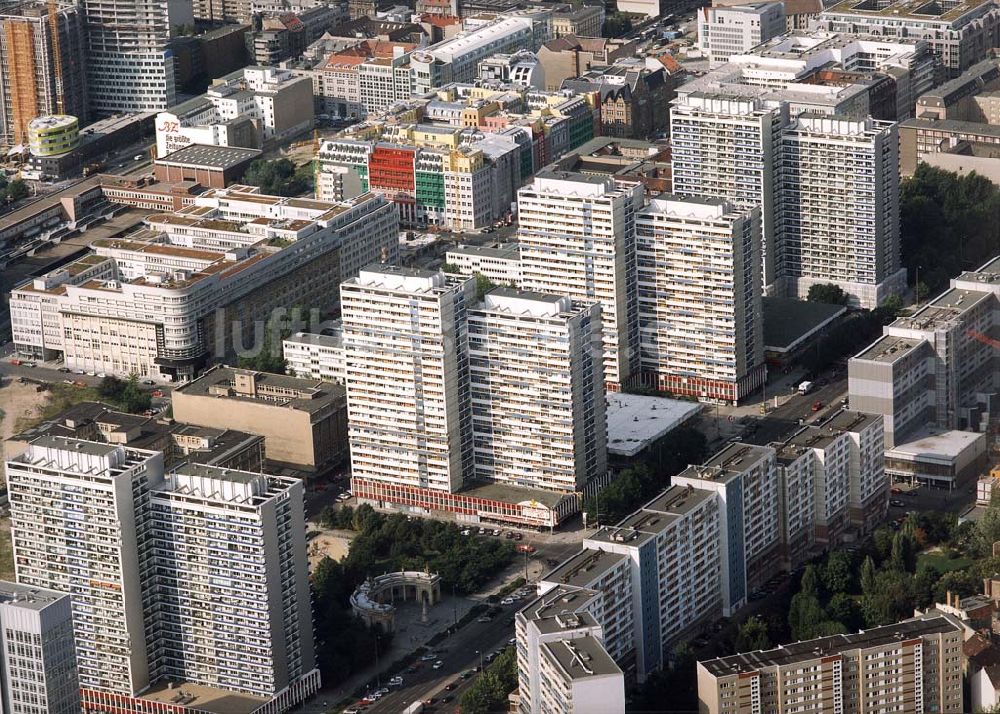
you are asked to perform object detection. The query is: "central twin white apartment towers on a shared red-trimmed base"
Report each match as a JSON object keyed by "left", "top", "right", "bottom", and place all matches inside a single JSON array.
[{"left": 344, "top": 265, "right": 607, "bottom": 522}]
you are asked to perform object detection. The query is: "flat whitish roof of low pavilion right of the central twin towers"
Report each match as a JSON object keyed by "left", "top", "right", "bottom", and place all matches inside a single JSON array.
[{"left": 607, "top": 392, "right": 703, "bottom": 456}]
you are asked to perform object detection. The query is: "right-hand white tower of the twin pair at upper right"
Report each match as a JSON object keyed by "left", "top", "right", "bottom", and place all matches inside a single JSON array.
[{"left": 781, "top": 114, "right": 906, "bottom": 309}]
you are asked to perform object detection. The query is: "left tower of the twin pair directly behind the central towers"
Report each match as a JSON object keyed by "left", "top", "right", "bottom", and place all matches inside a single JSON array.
[{"left": 517, "top": 171, "right": 643, "bottom": 389}]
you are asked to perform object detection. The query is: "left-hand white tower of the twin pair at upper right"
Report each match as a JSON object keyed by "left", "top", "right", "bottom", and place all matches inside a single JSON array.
[{"left": 670, "top": 90, "right": 788, "bottom": 288}]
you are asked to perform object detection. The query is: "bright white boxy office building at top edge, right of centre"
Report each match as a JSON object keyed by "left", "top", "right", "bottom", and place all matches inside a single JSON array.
[{"left": 698, "top": 2, "right": 786, "bottom": 64}]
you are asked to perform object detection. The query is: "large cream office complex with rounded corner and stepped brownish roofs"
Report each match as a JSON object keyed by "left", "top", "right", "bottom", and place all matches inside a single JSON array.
[{"left": 11, "top": 186, "right": 399, "bottom": 381}]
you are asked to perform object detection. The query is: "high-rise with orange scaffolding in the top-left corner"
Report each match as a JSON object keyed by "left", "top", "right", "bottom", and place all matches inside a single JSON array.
[{"left": 0, "top": 0, "right": 89, "bottom": 147}]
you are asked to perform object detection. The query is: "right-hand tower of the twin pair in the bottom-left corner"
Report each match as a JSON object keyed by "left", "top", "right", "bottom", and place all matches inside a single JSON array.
[{"left": 150, "top": 463, "right": 318, "bottom": 698}]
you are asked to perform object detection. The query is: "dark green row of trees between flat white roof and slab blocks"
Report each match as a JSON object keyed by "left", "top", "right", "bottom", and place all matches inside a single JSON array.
[{"left": 583, "top": 425, "right": 707, "bottom": 523}]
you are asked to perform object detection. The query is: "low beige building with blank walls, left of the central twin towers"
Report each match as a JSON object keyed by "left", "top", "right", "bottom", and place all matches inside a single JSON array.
[{"left": 172, "top": 367, "right": 347, "bottom": 472}]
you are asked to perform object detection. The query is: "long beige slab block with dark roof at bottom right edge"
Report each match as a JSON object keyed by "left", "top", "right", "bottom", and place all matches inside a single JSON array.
[{"left": 698, "top": 616, "right": 964, "bottom": 714}]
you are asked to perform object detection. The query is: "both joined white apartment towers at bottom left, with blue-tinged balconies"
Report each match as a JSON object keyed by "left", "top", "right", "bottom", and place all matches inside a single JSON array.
[{"left": 7, "top": 436, "right": 320, "bottom": 714}]
